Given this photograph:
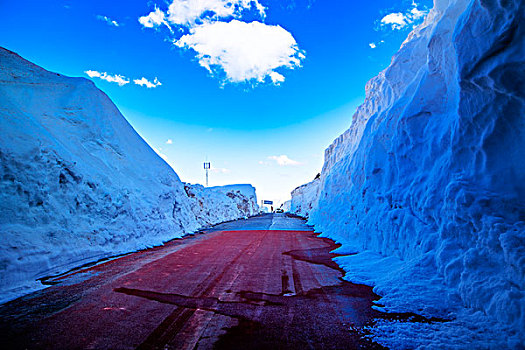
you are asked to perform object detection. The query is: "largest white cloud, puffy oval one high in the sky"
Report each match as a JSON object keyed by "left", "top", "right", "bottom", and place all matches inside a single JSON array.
[{"left": 174, "top": 20, "right": 305, "bottom": 84}]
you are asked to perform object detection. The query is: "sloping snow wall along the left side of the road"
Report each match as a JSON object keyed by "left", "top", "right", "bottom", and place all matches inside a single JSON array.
[{"left": 0, "top": 48, "right": 258, "bottom": 301}]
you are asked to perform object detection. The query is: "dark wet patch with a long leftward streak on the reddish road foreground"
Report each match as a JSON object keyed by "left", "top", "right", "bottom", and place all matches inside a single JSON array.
[{"left": 115, "top": 282, "right": 382, "bottom": 349}]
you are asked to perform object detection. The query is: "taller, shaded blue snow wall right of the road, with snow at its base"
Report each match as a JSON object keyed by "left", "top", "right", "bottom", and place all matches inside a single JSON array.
[{"left": 291, "top": 0, "right": 525, "bottom": 349}]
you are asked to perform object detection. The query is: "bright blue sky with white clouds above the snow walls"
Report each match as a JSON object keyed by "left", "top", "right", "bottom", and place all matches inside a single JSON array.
[{"left": 0, "top": 0, "right": 432, "bottom": 205}]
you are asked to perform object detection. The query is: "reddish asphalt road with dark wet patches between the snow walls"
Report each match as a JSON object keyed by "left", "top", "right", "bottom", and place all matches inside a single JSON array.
[{"left": 0, "top": 214, "right": 380, "bottom": 349}]
